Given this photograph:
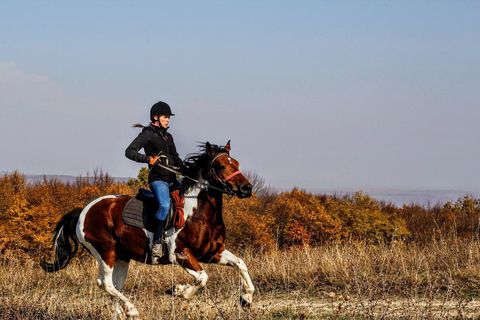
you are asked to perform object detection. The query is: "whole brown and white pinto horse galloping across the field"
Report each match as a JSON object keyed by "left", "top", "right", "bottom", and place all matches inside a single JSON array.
[{"left": 41, "top": 141, "right": 255, "bottom": 318}]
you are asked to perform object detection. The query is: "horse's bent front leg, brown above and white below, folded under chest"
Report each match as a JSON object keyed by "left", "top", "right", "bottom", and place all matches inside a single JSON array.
[{"left": 172, "top": 249, "right": 208, "bottom": 299}]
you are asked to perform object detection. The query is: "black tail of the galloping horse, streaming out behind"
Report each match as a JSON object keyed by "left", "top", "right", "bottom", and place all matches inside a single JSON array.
[{"left": 40, "top": 208, "right": 83, "bottom": 272}]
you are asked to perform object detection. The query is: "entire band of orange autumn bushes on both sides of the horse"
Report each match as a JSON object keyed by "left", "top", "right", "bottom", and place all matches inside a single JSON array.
[{"left": 0, "top": 170, "right": 480, "bottom": 254}]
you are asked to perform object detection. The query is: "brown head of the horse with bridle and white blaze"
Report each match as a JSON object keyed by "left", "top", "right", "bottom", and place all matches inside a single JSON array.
[{"left": 205, "top": 140, "right": 252, "bottom": 198}]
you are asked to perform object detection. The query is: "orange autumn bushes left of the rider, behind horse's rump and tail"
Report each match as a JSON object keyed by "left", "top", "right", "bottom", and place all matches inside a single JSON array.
[{"left": 0, "top": 171, "right": 131, "bottom": 252}]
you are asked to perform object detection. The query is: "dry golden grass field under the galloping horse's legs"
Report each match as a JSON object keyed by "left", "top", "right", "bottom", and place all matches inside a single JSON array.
[{"left": 0, "top": 240, "right": 480, "bottom": 319}]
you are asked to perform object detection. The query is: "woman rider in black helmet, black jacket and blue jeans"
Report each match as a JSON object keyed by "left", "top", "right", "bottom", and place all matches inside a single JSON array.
[{"left": 125, "top": 101, "right": 184, "bottom": 263}]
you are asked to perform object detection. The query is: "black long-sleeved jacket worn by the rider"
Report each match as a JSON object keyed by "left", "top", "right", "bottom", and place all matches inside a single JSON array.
[{"left": 125, "top": 125, "right": 183, "bottom": 183}]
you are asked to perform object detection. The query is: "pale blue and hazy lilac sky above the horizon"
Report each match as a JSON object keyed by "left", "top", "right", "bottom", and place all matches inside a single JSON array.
[{"left": 0, "top": 0, "right": 480, "bottom": 192}]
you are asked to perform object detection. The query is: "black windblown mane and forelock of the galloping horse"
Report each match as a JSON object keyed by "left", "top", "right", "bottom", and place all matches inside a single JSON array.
[{"left": 182, "top": 142, "right": 228, "bottom": 194}]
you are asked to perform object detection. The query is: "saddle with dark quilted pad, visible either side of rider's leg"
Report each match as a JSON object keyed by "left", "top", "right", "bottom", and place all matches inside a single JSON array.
[{"left": 122, "top": 189, "right": 185, "bottom": 232}]
